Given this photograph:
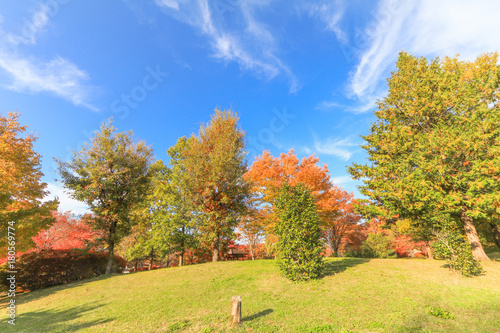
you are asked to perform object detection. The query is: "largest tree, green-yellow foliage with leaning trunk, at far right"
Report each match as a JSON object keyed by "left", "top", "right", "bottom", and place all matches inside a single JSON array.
[{"left": 349, "top": 52, "right": 500, "bottom": 260}]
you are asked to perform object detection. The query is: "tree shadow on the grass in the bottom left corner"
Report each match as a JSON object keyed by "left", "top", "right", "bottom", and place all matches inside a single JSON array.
[{"left": 0, "top": 304, "right": 115, "bottom": 332}]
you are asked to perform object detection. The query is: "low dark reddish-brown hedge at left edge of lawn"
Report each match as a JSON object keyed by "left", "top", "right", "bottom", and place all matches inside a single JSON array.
[{"left": 0, "top": 250, "right": 127, "bottom": 290}]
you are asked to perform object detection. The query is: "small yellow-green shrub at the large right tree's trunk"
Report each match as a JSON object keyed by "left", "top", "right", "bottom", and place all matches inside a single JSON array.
[{"left": 433, "top": 228, "right": 483, "bottom": 276}]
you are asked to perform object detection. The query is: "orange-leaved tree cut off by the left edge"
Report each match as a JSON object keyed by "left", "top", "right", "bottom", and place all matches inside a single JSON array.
[{"left": 0, "top": 112, "right": 58, "bottom": 251}]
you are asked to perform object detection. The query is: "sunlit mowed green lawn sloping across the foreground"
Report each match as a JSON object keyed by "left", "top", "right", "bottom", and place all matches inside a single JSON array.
[{"left": 0, "top": 258, "right": 500, "bottom": 332}]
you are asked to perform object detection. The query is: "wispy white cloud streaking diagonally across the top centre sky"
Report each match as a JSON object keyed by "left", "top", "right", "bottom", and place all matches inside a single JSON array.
[{"left": 155, "top": 0, "right": 300, "bottom": 93}]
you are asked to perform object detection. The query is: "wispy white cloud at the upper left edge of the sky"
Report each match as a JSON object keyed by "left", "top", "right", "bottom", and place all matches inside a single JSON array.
[{"left": 0, "top": 5, "right": 97, "bottom": 110}]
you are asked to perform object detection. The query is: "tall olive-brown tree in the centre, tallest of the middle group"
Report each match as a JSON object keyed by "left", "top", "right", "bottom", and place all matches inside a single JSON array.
[{"left": 183, "top": 109, "right": 249, "bottom": 261}]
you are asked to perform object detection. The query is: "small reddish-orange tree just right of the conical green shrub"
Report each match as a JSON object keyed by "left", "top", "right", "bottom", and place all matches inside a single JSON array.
[{"left": 322, "top": 191, "right": 361, "bottom": 255}]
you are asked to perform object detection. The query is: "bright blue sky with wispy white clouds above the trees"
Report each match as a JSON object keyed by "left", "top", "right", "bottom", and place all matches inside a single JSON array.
[{"left": 0, "top": 0, "right": 500, "bottom": 212}]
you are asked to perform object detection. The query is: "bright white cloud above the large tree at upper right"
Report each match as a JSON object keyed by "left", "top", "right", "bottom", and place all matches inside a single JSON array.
[{"left": 349, "top": 0, "right": 500, "bottom": 110}]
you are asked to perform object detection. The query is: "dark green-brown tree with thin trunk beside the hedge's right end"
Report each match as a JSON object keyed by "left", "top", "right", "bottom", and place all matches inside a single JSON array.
[{"left": 58, "top": 122, "right": 153, "bottom": 274}]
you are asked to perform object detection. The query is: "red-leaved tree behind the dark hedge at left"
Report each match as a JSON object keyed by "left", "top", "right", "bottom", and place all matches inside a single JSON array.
[{"left": 33, "top": 211, "right": 103, "bottom": 250}]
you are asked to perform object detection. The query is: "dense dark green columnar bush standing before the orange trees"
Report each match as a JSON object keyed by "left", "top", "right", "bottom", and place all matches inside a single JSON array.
[{"left": 275, "top": 183, "right": 323, "bottom": 281}]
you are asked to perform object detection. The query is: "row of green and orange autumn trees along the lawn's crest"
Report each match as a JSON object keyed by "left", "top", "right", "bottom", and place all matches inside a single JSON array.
[{"left": 0, "top": 52, "right": 500, "bottom": 275}]
